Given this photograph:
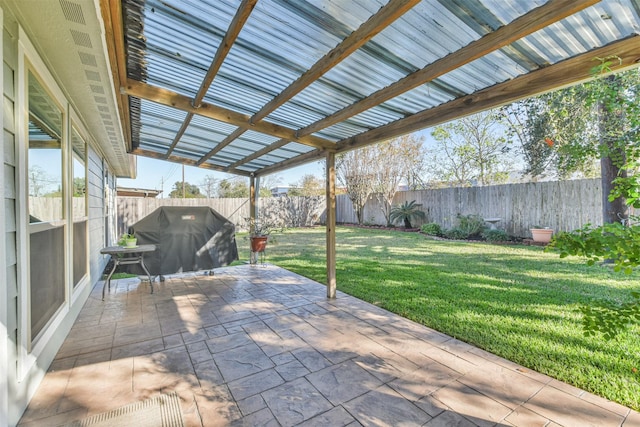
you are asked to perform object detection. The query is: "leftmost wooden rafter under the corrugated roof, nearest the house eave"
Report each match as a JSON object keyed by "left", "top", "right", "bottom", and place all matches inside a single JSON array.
[{"left": 165, "top": 0, "right": 258, "bottom": 160}]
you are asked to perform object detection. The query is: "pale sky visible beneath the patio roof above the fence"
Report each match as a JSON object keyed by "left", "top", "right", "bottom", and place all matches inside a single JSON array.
[{"left": 118, "top": 129, "right": 433, "bottom": 197}]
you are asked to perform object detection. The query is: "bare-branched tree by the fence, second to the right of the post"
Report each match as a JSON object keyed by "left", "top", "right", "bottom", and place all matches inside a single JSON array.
[{"left": 373, "top": 135, "right": 424, "bottom": 226}]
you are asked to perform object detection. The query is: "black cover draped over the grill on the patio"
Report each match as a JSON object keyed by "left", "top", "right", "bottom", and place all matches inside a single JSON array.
[{"left": 129, "top": 206, "right": 238, "bottom": 275}]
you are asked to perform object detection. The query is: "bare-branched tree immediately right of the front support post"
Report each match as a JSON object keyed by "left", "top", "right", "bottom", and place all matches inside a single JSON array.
[{"left": 336, "top": 146, "right": 376, "bottom": 224}]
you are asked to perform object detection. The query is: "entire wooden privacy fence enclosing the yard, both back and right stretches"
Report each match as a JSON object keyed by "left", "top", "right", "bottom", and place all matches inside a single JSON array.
[{"left": 118, "top": 179, "right": 602, "bottom": 237}]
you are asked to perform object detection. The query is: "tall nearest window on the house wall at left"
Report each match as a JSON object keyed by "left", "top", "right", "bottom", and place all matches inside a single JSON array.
[{"left": 27, "top": 71, "right": 66, "bottom": 341}]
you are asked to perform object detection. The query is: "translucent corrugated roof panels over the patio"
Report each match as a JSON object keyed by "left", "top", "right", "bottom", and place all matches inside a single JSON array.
[{"left": 123, "top": 0, "right": 640, "bottom": 176}]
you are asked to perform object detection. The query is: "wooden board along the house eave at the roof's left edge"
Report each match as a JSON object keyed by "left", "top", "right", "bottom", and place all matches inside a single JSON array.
[{"left": 100, "top": 0, "right": 133, "bottom": 151}]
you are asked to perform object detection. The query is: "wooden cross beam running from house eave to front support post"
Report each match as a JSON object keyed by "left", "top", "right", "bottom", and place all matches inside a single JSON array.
[{"left": 122, "top": 79, "right": 335, "bottom": 149}]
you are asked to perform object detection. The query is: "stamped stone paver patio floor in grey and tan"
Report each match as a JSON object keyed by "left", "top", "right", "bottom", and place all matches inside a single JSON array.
[{"left": 20, "top": 265, "right": 640, "bottom": 427}]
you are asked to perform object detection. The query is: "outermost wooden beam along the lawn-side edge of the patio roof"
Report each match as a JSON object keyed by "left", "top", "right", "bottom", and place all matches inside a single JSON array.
[{"left": 257, "top": 35, "right": 640, "bottom": 175}]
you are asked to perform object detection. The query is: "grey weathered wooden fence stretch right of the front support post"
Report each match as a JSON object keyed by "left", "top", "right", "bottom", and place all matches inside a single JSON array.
[{"left": 336, "top": 179, "right": 602, "bottom": 237}]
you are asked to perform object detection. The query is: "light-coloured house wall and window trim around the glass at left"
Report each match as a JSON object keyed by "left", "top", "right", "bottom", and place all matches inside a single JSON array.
[{"left": 0, "top": 5, "right": 116, "bottom": 426}]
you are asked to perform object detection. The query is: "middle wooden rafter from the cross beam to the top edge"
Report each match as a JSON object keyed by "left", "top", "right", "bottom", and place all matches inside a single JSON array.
[{"left": 252, "top": 0, "right": 420, "bottom": 123}]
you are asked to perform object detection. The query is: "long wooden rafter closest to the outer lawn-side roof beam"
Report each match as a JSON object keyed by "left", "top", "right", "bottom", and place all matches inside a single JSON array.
[{"left": 298, "top": 0, "right": 600, "bottom": 135}]
